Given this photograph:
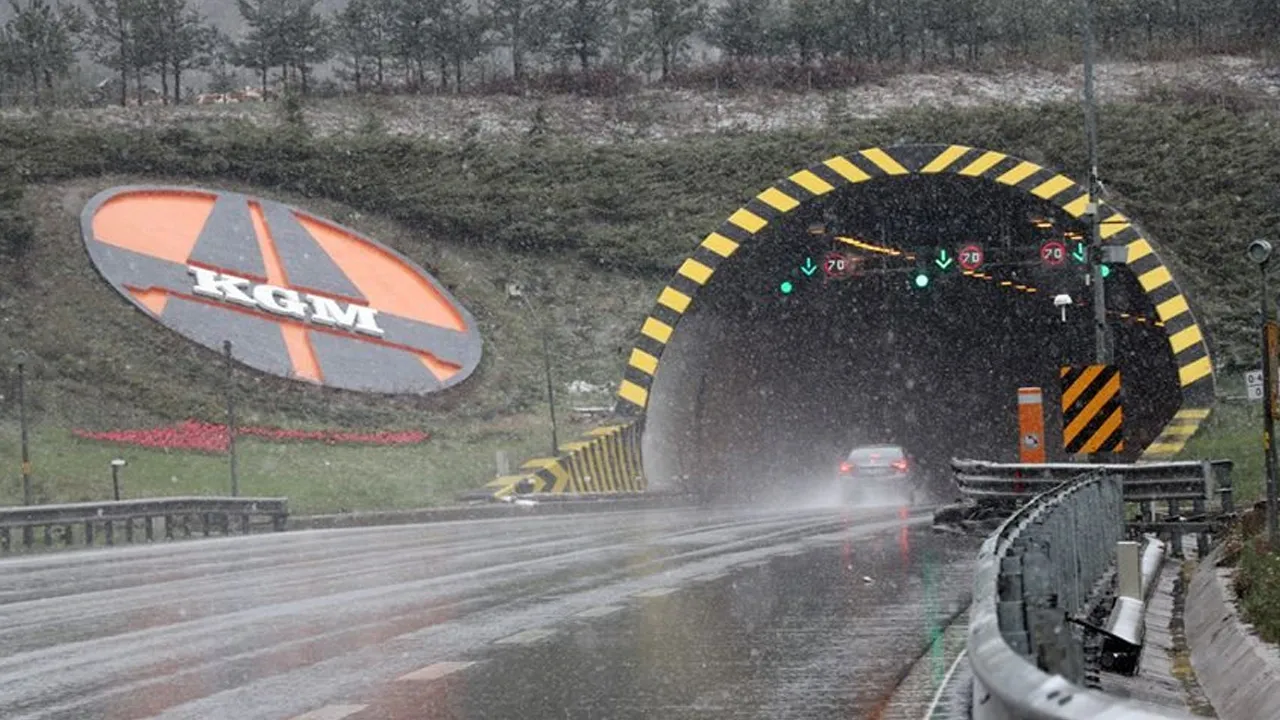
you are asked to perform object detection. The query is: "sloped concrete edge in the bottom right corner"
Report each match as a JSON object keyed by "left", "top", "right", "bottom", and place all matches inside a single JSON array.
[{"left": 1184, "top": 546, "right": 1280, "bottom": 720}]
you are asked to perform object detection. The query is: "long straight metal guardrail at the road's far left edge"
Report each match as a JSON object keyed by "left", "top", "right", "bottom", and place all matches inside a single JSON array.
[{"left": 0, "top": 497, "right": 289, "bottom": 552}]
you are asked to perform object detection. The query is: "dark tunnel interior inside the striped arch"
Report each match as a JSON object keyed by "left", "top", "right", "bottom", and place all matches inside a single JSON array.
[{"left": 643, "top": 176, "right": 1181, "bottom": 500}]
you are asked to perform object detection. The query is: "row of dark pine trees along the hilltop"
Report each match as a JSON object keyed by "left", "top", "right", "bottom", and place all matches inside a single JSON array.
[{"left": 0, "top": 0, "right": 1280, "bottom": 104}]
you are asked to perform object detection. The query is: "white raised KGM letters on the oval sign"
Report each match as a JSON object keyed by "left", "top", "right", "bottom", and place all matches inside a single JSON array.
[{"left": 187, "top": 265, "right": 385, "bottom": 337}]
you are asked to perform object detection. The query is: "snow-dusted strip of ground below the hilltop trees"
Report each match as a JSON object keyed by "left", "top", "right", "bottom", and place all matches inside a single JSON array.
[{"left": 0, "top": 56, "right": 1280, "bottom": 142}]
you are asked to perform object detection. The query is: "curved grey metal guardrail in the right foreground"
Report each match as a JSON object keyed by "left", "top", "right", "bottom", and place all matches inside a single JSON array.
[{"left": 968, "top": 469, "right": 1193, "bottom": 720}]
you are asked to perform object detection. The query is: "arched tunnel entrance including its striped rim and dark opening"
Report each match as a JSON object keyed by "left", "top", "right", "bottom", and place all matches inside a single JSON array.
[{"left": 621, "top": 146, "right": 1212, "bottom": 497}]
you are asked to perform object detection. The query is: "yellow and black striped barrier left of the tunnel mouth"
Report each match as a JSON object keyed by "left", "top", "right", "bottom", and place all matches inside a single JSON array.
[{"left": 485, "top": 421, "right": 646, "bottom": 500}]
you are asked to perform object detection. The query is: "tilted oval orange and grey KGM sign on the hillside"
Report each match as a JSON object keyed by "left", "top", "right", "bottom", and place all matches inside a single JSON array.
[{"left": 81, "top": 186, "right": 481, "bottom": 393}]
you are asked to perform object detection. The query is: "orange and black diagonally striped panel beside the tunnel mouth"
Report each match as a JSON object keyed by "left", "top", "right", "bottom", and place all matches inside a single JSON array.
[{"left": 1059, "top": 365, "right": 1124, "bottom": 455}]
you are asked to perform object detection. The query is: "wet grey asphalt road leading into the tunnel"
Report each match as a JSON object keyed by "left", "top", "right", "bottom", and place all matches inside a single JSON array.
[{"left": 0, "top": 509, "right": 978, "bottom": 720}]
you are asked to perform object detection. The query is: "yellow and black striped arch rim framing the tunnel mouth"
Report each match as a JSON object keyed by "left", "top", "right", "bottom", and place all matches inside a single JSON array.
[{"left": 618, "top": 145, "right": 1215, "bottom": 459}]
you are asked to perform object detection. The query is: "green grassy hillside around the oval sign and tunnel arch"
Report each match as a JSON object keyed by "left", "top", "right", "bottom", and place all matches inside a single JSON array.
[{"left": 0, "top": 96, "right": 1280, "bottom": 507}]
